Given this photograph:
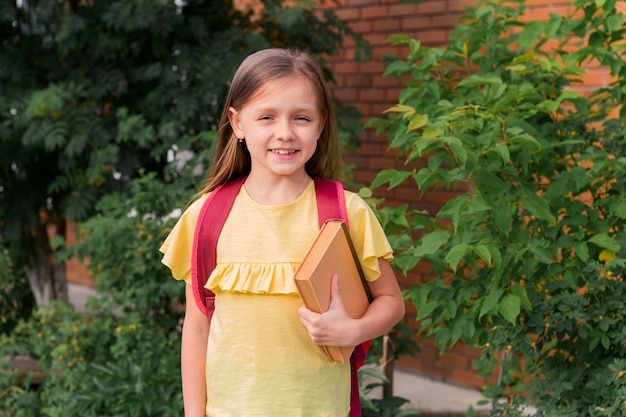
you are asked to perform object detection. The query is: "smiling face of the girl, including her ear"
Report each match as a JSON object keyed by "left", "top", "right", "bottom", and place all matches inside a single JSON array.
[{"left": 229, "top": 76, "right": 325, "bottom": 180}]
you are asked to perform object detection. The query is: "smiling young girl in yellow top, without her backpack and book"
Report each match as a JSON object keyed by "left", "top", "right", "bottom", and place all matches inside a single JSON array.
[{"left": 161, "top": 49, "right": 404, "bottom": 417}]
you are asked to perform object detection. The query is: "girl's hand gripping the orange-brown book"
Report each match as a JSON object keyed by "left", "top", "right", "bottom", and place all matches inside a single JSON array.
[{"left": 298, "top": 275, "right": 359, "bottom": 346}]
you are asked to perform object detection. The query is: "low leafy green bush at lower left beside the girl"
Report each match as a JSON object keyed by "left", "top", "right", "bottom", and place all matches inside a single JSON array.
[{"left": 0, "top": 171, "right": 185, "bottom": 417}]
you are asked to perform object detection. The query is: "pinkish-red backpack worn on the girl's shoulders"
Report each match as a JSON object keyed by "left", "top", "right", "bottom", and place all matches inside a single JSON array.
[{"left": 191, "top": 177, "right": 371, "bottom": 417}]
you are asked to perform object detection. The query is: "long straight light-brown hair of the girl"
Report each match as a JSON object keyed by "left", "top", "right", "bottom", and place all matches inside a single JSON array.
[{"left": 197, "top": 48, "right": 339, "bottom": 196}]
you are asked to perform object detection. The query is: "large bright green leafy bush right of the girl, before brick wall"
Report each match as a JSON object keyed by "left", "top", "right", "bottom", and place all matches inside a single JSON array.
[{"left": 371, "top": 0, "right": 626, "bottom": 417}]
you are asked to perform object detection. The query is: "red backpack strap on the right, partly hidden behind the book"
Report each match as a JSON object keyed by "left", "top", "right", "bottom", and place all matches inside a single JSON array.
[{"left": 315, "top": 178, "right": 371, "bottom": 417}]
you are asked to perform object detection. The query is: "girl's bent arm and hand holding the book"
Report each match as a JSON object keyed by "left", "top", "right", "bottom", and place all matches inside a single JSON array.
[{"left": 298, "top": 259, "right": 404, "bottom": 346}]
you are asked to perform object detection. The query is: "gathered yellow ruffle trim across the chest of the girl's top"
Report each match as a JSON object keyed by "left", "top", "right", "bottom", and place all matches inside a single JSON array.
[{"left": 206, "top": 262, "right": 299, "bottom": 294}]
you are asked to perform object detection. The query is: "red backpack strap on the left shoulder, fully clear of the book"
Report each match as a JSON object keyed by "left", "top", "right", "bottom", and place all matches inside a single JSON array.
[{"left": 191, "top": 177, "right": 246, "bottom": 320}]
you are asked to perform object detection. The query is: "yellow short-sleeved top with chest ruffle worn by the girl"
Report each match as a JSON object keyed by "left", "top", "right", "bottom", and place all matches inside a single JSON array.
[{"left": 161, "top": 183, "right": 392, "bottom": 417}]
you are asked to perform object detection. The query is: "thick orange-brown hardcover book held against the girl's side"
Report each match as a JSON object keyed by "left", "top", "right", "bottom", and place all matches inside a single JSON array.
[{"left": 294, "top": 220, "right": 372, "bottom": 363}]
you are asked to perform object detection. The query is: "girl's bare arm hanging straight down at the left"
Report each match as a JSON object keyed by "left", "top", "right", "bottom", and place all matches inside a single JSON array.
[{"left": 181, "top": 284, "right": 209, "bottom": 417}]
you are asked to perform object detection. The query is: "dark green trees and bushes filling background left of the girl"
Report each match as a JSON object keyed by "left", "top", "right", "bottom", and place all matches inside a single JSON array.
[{"left": 0, "top": 0, "right": 369, "bottom": 417}]
